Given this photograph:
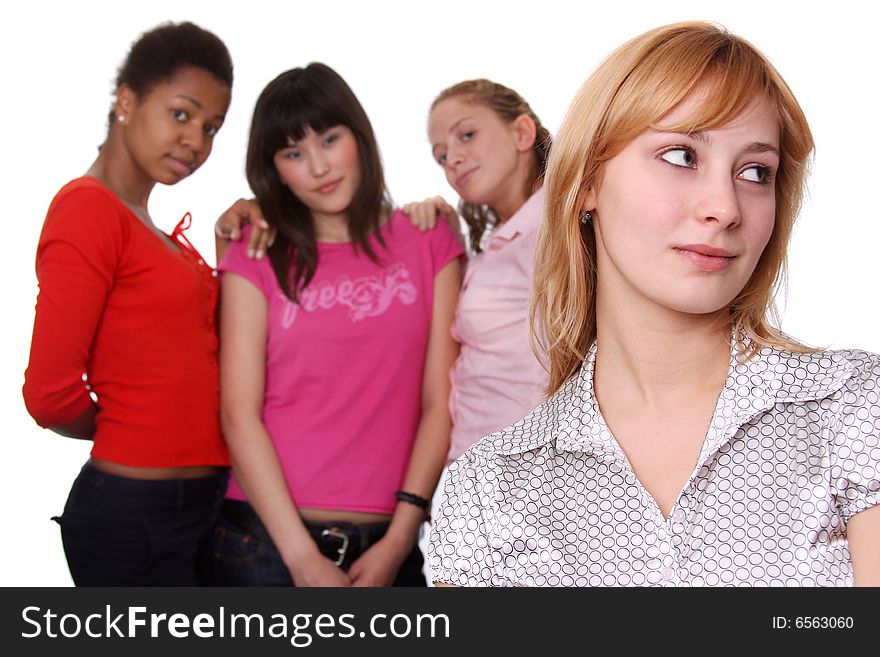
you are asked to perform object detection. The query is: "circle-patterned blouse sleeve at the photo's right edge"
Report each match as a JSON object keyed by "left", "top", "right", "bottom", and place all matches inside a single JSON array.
[{"left": 830, "top": 352, "right": 880, "bottom": 520}]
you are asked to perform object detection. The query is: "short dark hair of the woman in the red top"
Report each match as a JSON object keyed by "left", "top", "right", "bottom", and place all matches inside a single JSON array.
[{"left": 109, "top": 22, "right": 232, "bottom": 125}]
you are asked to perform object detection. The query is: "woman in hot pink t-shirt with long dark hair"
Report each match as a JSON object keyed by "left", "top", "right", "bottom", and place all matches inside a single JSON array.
[{"left": 214, "top": 63, "right": 462, "bottom": 586}]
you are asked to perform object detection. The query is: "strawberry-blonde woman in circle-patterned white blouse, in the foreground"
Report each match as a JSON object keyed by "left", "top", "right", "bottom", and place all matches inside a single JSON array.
[{"left": 429, "top": 23, "right": 880, "bottom": 586}]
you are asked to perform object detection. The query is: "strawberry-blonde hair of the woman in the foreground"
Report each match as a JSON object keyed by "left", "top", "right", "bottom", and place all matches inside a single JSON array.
[{"left": 530, "top": 22, "right": 813, "bottom": 394}]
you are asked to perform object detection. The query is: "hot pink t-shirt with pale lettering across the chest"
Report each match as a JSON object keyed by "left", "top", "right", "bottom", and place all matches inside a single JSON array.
[{"left": 219, "top": 211, "right": 463, "bottom": 514}]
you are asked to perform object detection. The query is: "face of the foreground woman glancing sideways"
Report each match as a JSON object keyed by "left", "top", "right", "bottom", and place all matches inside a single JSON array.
[{"left": 586, "top": 88, "right": 779, "bottom": 314}]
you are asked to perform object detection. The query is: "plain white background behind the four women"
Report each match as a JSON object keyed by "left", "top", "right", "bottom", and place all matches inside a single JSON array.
[{"left": 0, "top": 0, "right": 880, "bottom": 586}]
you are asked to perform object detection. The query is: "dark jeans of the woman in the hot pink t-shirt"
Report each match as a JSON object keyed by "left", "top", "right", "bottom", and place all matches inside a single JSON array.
[{"left": 213, "top": 500, "right": 427, "bottom": 586}]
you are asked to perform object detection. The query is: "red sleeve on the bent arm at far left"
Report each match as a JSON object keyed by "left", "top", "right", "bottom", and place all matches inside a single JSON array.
[{"left": 23, "top": 188, "right": 127, "bottom": 427}]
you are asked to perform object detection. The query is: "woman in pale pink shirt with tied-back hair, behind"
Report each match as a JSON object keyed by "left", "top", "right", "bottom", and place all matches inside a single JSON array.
[{"left": 405, "top": 79, "right": 551, "bottom": 463}]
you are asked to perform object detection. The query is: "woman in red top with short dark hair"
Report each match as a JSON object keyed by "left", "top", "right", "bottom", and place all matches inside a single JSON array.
[{"left": 24, "top": 23, "right": 232, "bottom": 586}]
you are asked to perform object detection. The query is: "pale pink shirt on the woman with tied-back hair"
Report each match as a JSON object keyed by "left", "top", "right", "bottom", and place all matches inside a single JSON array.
[{"left": 448, "top": 189, "right": 549, "bottom": 463}]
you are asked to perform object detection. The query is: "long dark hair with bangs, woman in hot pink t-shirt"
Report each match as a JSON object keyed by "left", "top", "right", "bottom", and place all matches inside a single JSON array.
[{"left": 245, "top": 62, "right": 391, "bottom": 302}]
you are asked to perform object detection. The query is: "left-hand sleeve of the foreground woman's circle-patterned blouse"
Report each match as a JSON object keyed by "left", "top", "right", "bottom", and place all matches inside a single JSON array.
[{"left": 428, "top": 452, "right": 504, "bottom": 587}]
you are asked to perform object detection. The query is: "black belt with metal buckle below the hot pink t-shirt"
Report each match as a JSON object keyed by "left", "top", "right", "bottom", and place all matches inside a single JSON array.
[{"left": 220, "top": 500, "right": 389, "bottom": 568}]
